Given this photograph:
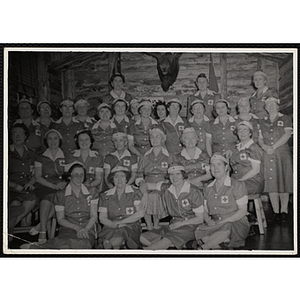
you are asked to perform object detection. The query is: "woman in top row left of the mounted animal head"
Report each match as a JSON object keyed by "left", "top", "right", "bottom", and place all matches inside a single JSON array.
[{"left": 103, "top": 73, "right": 132, "bottom": 106}]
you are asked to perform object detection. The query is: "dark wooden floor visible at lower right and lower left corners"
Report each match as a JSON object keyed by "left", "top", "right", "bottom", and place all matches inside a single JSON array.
[{"left": 9, "top": 202, "right": 294, "bottom": 250}]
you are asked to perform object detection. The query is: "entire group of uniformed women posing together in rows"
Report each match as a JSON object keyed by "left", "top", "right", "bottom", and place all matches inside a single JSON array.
[{"left": 9, "top": 71, "right": 293, "bottom": 249}]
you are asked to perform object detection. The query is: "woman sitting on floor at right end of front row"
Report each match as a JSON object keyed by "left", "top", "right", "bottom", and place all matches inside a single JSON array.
[{"left": 195, "top": 153, "right": 250, "bottom": 250}]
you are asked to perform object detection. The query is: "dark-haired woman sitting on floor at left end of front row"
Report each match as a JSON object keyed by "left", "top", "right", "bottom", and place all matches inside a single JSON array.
[{"left": 21, "top": 162, "right": 99, "bottom": 249}]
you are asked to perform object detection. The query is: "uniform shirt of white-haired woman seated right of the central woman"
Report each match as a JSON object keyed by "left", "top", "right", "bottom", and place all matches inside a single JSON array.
[{"left": 176, "top": 147, "right": 209, "bottom": 180}]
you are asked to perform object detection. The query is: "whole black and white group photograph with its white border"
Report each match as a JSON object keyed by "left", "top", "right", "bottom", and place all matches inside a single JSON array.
[{"left": 3, "top": 44, "right": 298, "bottom": 257}]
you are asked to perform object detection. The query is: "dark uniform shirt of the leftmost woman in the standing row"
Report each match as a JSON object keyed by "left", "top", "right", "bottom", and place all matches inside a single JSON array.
[{"left": 14, "top": 119, "right": 48, "bottom": 152}]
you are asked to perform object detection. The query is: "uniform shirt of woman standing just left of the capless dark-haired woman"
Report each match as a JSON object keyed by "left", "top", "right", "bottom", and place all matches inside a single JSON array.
[{"left": 127, "top": 117, "right": 158, "bottom": 154}]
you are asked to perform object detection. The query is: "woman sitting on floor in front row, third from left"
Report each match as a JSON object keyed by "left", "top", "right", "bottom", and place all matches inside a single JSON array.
[{"left": 140, "top": 163, "right": 204, "bottom": 250}]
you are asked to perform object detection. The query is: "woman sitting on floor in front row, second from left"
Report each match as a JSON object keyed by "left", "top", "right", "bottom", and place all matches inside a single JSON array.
[{"left": 98, "top": 166, "right": 147, "bottom": 249}]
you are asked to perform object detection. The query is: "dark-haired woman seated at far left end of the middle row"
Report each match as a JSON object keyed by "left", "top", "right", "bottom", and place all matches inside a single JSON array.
[{"left": 8, "top": 124, "right": 36, "bottom": 238}]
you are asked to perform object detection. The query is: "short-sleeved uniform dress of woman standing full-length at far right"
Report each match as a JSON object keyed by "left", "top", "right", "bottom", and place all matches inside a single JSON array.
[{"left": 260, "top": 113, "right": 293, "bottom": 193}]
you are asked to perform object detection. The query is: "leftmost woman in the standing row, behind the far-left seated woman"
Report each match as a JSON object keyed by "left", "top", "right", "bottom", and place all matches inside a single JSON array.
[{"left": 14, "top": 98, "right": 48, "bottom": 152}]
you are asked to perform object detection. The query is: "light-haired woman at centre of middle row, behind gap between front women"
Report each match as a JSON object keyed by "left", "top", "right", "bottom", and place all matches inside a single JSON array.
[{"left": 136, "top": 127, "right": 175, "bottom": 230}]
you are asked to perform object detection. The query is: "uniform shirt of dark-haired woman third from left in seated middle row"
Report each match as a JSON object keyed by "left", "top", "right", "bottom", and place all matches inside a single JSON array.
[{"left": 67, "top": 149, "right": 103, "bottom": 182}]
